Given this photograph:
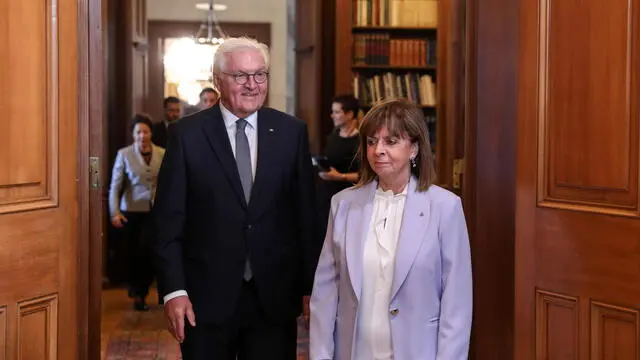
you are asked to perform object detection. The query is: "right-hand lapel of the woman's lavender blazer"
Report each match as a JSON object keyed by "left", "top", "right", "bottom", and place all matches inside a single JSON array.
[{"left": 391, "top": 177, "right": 430, "bottom": 299}]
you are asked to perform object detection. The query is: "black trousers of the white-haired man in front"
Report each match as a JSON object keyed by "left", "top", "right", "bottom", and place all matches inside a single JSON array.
[{"left": 181, "top": 282, "right": 297, "bottom": 360}]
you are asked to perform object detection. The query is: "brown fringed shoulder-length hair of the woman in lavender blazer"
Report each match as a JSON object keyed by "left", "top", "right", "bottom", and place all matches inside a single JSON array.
[{"left": 356, "top": 99, "right": 436, "bottom": 191}]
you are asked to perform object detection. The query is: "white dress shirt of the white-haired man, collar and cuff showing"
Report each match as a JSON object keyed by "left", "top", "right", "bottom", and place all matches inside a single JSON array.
[{"left": 163, "top": 102, "right": 258, "bottom": 304}]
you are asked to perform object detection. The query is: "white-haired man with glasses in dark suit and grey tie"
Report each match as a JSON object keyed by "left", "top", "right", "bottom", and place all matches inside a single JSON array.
[{"left": 154, "top": 38, "right": 320, "bottom": 360}]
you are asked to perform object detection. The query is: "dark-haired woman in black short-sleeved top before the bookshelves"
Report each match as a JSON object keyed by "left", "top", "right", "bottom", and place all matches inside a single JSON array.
[{"left": 317, "top": 94, "right": 360, "bottom": 248}]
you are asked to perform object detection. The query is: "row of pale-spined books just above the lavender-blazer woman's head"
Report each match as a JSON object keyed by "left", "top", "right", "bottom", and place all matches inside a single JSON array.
[{"left": 353, "top": 72, "right": 436, "bottom": 107}]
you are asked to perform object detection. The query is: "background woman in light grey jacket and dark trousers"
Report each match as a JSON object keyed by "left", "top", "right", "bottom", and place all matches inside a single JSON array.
[{"left": 109, "top": 114, "right": 164, "bottom": 311}]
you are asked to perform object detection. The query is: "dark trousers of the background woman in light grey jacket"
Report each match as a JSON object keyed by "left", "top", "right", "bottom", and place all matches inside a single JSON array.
[{"left": 122, "top": 212, "right": 154, "bottom": 299}]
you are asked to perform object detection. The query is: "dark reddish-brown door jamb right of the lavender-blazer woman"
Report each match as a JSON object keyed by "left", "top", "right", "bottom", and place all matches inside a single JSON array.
[{"left": 464, "top": 0, "right": 520, "bottom": 360}]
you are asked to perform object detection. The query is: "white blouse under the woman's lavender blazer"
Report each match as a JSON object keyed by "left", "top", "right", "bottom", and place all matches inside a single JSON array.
[{"left": 353, "top": 186, "right": 407, "bottom": 360}]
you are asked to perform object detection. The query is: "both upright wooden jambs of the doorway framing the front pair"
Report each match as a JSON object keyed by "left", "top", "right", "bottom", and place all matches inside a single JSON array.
[{"left": 77, "top": 0, "right": 527, "bottom": 359}]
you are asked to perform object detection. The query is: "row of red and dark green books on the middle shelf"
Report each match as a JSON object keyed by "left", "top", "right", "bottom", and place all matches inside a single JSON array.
[{"left": 353, "top": 34, "right": 436, "bottom": 67}]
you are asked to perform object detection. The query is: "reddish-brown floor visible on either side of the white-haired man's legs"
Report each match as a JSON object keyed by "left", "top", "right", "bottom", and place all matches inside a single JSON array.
[{"left": 101, "top": 289, "right": 308, "bottom": 360}]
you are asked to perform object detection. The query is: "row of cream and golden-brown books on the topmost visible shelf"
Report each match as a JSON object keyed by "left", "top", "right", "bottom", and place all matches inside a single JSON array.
[{"left": 352, "top": 0, "right": 438, "bottom": 27}]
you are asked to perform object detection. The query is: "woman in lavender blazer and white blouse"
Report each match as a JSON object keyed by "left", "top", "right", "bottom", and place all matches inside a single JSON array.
[{"left": 310, "top": 100, "right": 472, "bottom": 360}]
